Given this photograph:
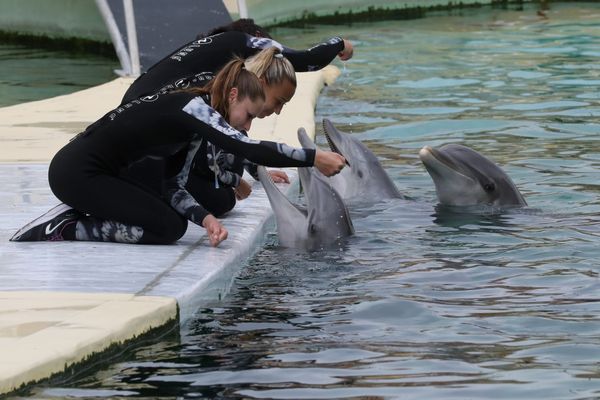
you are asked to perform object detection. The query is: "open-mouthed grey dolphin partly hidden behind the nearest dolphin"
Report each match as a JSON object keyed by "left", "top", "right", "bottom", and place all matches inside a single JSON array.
[{"left": 323, "top": 118, "right": 404, "bottom": 201}]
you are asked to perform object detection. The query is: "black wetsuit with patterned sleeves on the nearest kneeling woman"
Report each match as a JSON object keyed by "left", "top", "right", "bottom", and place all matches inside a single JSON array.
[{"left": 48, "top": 92, "right": 315, "bottom": 244}]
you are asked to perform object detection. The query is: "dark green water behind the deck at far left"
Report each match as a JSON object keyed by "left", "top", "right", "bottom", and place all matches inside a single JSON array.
[{"left": 0, "top": 43, "right": 119, "bottom": 107}]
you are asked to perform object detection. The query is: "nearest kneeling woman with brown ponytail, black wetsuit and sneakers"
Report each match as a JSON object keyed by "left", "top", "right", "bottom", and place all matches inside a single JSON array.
[{"left": 11, "top": 59, "right": 344, "bottom": 246}]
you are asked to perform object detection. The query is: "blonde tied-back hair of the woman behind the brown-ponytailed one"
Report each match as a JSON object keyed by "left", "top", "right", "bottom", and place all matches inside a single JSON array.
[{"left": 245, "top": 47, "right": 297, "bottom": 87}]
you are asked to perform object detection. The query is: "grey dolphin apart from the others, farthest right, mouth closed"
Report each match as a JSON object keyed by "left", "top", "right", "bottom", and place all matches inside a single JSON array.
[{"left": 419, "top": 144, "right": 527, "bottom": 207}]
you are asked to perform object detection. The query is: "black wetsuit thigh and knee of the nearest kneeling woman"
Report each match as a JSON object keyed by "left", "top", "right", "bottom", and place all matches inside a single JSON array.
[{"left": 48, "top": 140, "right": 187, "bottom": 244}]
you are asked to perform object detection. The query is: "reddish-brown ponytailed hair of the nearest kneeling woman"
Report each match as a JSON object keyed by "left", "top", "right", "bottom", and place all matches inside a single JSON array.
[{"left": 185, "top": 57, "right": 265, "bottom": 120}]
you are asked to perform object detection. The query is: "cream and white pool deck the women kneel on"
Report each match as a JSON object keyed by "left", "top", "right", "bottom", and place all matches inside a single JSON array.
[{"left": 0, "top": 66, "right": 339, "bottom": 394}]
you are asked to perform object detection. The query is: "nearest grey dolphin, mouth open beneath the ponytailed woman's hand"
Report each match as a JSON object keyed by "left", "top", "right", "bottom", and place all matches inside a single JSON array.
[{"left": 258, "top": 128, "right": 354, "bottom": 250}]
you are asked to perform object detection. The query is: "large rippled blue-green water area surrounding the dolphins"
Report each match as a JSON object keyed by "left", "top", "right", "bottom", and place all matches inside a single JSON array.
[{"left": 15, "top": 3, "right": 600, "bottom": 400}]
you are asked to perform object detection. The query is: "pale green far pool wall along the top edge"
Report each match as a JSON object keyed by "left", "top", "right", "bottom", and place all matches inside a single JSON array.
[{"left": 0, "top": 0, "right": 527, "bottom": 44}]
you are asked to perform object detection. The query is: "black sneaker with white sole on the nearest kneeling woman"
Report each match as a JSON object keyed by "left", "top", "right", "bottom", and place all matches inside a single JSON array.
[{"left": 10, "top": 203, "right": 82, "bottom": 242}]
